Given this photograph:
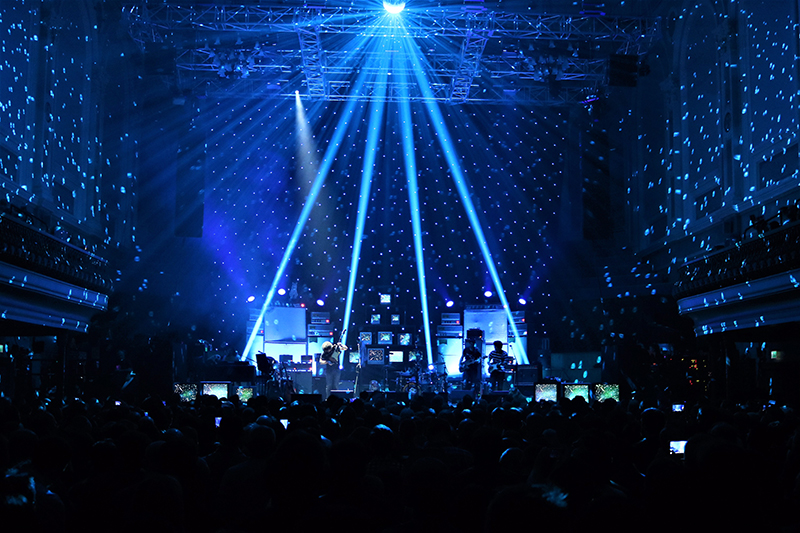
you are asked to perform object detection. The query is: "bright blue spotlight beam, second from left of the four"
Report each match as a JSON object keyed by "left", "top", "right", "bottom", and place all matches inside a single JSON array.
[{"left": 342, "top": 56, "right": 388, "bottom": 354}]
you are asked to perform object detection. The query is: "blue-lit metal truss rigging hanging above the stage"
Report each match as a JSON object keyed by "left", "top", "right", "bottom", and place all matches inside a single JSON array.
[{"left": 124, "top": 1, "right": 660, "bottom": 104}]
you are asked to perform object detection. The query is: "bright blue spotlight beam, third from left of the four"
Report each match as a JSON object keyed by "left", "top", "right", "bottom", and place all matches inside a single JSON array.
[{"left": 400, "top": 59, "right": 433, "bottom": 367}]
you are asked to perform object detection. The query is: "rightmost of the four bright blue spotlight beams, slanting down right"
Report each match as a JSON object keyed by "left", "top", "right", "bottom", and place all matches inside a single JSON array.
[{"left": 404, "top": 23, "right": 528, "bottom": 364}]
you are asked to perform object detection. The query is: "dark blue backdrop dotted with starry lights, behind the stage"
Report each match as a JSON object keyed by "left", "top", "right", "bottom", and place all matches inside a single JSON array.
[{"left": 203, "top": 89, "right": 563, "bottom": 348}]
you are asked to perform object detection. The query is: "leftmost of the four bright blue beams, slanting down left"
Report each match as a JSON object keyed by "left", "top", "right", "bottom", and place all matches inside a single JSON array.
[{"left": 242, "top": 77, "right": 363, "bottom": 360}]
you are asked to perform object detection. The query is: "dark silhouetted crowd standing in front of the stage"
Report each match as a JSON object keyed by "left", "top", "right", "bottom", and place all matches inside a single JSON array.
[{"left": 0, "top": 391, "right": 800, "bottom": 533}]
